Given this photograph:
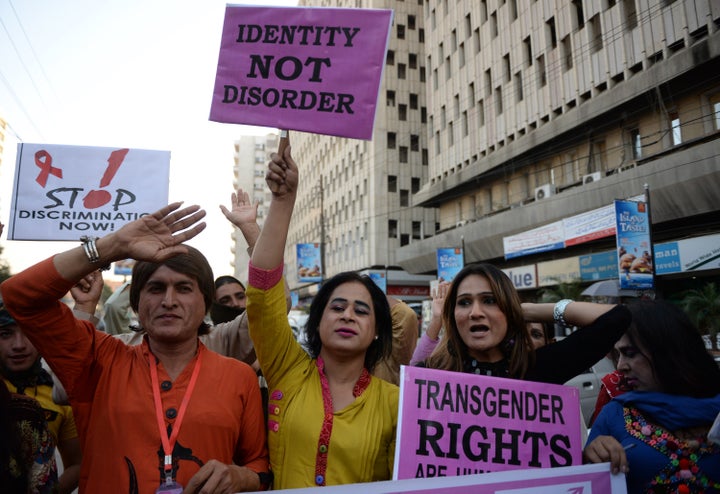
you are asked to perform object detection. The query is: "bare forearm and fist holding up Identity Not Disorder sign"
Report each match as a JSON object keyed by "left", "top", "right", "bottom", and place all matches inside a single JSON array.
[{"left": 251, "top": 146, "right": 298, "bottom": 270}]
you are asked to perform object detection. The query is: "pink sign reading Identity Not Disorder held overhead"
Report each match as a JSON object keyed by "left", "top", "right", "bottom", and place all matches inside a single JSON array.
[{"left": 210, "top": 5, "right": 392, "bottom": 139}]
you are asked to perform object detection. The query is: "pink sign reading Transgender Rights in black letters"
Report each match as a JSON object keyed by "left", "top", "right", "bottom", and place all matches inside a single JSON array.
[{"left": 393, "top": 366, "right": 582, "bottom": 479}]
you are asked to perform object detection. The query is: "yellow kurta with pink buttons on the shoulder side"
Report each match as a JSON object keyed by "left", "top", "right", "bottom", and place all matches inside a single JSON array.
[{"left": 247, "top": 274, "right": 399, "bottom": 489}]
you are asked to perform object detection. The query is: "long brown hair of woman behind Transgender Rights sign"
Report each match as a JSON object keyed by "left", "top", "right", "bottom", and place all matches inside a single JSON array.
[{"left": 427, "top": 263, "right": 535, "bottom": 379}]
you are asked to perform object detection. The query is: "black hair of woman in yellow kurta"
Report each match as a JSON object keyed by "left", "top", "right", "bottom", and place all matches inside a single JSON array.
[{"left": 305, "top": 271, "right": 392, "bottom": 372}]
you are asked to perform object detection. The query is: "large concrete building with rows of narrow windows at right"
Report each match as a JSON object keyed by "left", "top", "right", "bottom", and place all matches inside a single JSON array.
[{"left": 396, "top": 0, "right": 720, "bottom": 298}]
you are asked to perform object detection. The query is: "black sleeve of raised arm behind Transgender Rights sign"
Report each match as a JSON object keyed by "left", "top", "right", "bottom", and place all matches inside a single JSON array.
[{"left": 525, "top": 305, "right": 632, "bottom": 384}]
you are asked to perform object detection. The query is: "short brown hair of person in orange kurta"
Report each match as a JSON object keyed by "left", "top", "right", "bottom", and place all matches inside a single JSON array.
[{"left": 130, "top": 245, "right": 215, "bottom": 335}]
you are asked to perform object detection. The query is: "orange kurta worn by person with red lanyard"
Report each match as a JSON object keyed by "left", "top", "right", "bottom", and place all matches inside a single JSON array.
[{"left": 0, "top": 259, "right": 268, "bottom": 493}]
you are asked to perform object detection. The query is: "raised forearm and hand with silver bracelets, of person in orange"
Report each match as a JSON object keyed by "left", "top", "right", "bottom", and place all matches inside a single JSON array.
[{"left": 53, "top": 202, "right": 205, "bottom": 281}]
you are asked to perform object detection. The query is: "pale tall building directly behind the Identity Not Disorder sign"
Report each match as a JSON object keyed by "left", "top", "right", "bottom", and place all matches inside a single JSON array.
[{"left": 285, "top": 0, "right": 437, "bottom": 301}]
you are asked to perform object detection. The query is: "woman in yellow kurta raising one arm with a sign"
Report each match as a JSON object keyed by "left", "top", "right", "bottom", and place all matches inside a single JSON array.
[{"left": 247, "top": 147, "right": 399, "bottom": 489}]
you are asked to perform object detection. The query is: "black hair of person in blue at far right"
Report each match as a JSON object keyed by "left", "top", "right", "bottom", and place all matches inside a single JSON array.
[{"left": 625, "top": 300, "right": 720, "bottom": 398}]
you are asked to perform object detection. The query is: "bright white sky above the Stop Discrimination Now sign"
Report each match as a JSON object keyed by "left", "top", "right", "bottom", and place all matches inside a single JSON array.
[{"left": 0, "top": 0, "right": 297, "bottom": 282}]
